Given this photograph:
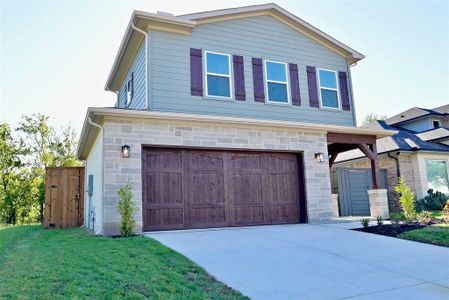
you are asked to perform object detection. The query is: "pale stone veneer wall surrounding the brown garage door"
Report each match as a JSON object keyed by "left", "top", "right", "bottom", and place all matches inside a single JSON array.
[{"left": 103, "top": 119, "right": 333, "bottom": 235}]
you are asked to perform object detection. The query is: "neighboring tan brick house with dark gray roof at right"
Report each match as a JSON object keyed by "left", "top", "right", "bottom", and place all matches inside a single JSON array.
[{"left": 333, "top": 105, "right": 449, "bottom": 211}]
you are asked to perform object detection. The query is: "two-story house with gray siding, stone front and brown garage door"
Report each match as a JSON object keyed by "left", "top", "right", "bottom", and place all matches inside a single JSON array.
[{"left": 78, "top": 4, "right": 393, "bottom": 235}]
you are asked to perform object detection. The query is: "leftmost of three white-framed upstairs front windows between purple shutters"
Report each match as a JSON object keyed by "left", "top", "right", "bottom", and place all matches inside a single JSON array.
[{"left": 205, "top": 51, "right": 232, "bottom": 99}]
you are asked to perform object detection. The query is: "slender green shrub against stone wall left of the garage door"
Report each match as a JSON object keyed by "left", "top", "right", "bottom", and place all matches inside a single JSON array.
[{"left": 117, "top": 183, "right": 137, "bottom": 236}]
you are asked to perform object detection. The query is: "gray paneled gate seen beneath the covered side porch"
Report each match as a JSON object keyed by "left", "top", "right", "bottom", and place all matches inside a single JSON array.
[{"left": 331, "top": 168, "right": 388, "bottom": 217}]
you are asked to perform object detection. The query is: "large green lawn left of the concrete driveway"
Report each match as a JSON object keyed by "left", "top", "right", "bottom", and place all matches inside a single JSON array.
[{"left": 0, "top": 226, "right": 246, "bottom": 299}]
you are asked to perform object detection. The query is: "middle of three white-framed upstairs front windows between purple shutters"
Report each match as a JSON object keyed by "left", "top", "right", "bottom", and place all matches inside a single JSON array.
[{"left": 265, "top": 60, "right": 290, "bottom": 103}]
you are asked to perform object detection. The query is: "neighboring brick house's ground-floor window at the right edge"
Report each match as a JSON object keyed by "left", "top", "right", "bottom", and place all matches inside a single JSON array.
[{"left": 426, "top": 159, "right": 449, "bottom": 194}]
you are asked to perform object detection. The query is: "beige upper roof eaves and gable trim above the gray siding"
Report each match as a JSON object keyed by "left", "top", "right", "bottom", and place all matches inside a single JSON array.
[{"left": 105, "top": 3, "right": 364, "bottom": 91}]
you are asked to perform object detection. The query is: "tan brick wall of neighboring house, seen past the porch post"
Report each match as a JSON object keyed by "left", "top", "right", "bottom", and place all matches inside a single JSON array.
[{"left": 332, "top": 153, "right": 416, "bottom": 212}]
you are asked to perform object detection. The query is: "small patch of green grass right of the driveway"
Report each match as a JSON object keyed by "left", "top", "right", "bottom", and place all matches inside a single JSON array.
[{"left": 399, "top": 224, "right": 449, "bottom": 247}]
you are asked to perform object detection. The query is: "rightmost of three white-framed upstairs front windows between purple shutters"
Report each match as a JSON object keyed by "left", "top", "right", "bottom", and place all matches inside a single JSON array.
[{"left": 318, "top": 69, "right": 340, "bottom": 109}]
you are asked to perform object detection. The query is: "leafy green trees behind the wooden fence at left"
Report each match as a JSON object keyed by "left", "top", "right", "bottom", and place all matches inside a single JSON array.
[{"left": 0, "top": 114, "right": 81, "bottom": 224}]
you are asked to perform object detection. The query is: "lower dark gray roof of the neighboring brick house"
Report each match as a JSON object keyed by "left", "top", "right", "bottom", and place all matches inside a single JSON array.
[{"left": 337, "top": 120, "right": 449, "bottom": 162}]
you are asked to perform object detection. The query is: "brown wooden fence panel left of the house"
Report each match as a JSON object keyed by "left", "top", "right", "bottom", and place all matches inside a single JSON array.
[{"left": 44, "top": 167, "right": 84, "bottom": 228}]
